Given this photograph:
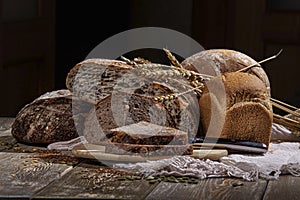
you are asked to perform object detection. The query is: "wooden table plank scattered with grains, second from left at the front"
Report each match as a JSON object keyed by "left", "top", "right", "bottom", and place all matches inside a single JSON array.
[{"left": 33, "top": 163, "right": 156, "bottom": 199}]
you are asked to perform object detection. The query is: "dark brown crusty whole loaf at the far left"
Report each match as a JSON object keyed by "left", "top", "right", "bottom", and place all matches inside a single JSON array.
[{"left": 12, "top": 90, "right": 91, "bottom": 144}]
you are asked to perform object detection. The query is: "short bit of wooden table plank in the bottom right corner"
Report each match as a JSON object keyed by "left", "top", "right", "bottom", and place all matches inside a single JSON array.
[{"left": 263, "top": 175, "right": 300, "bottom": 200}]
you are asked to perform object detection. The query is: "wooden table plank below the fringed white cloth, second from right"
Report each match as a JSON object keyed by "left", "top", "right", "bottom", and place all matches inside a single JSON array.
[{"left": 146, "top": 178, "right": 267, "bottom": 200}]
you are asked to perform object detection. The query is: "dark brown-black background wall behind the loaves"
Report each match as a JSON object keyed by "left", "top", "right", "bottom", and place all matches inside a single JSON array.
[{"left": 0, "top": 0, "right": 300, "bottom": 116}]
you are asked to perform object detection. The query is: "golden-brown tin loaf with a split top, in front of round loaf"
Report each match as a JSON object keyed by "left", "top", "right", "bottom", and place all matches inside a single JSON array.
[{"left": 199, "top": 72, "right": 272, "bottom": 145}]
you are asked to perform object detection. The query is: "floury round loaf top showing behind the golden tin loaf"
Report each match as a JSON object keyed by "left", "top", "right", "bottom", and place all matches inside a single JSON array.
[{"left": 181, "top": 49, "right": 270, "bottom": 90}]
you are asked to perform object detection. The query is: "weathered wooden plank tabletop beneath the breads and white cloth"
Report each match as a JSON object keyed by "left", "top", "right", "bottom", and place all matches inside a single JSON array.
[{"left": 0, "top": 118, "right": 300, "bottom": 200}]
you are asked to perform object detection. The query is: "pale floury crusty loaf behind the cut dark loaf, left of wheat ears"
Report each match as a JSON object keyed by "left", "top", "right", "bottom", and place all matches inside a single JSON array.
[{"left": 66, "top": 59, "right": 136, "bottom": 103}]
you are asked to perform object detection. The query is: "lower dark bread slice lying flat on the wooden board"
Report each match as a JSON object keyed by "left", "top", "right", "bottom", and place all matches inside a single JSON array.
[{"left": 105, "top": 143, "right": 193, "bottom": 156}]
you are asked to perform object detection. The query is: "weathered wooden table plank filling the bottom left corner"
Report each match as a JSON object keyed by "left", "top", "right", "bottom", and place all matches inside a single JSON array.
[{"left": 0, "top": 152, "right": 72, "bottom": 199}]
